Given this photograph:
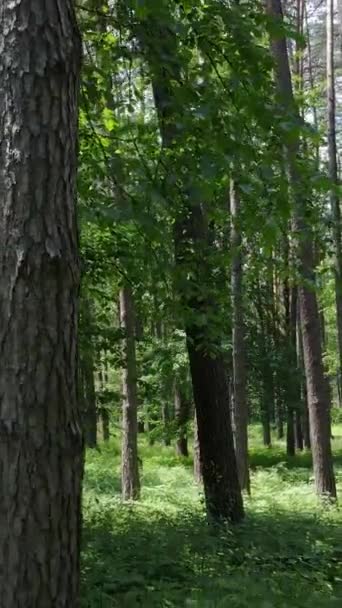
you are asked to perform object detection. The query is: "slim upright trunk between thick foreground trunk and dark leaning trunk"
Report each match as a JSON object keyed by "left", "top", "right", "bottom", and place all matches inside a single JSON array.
[{"left": 120, "top": 286, "right": 140, "bottom": 500}]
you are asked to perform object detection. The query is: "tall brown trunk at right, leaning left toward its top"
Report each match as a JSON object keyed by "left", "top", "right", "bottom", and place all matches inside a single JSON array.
[{"left": 267, "top": 0, "right": 336, "bottom": 497}]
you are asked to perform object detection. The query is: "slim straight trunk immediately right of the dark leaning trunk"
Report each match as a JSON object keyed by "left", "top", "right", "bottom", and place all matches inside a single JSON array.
[{"left": 230, "top": 180, "right": 250, "bottom": 493}]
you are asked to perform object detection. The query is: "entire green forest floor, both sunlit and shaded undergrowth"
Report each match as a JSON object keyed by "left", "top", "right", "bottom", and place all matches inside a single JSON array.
[{"left": 82, "top": 426, "right": 342, "bottom": 608}]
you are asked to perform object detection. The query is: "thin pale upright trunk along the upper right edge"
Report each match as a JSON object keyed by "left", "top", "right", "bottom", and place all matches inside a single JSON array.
[{"left": 327, "top": 0, "right": 342, "bottom": 400}]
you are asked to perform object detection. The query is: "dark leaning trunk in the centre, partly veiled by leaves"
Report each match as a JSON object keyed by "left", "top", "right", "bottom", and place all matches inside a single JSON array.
[{"left": 137, "top": 11, "right": 244, "bottom": 522}]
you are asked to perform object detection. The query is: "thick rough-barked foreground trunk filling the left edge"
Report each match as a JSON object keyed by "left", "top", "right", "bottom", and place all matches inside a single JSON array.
[{"left": 0, "top": 0, "right": 83, "bottom": 608}]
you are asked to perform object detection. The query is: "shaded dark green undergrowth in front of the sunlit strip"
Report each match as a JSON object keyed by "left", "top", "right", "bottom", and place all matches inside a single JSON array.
[{"left": 82, "top": 477, "right": 342, "bottom": 608}]
